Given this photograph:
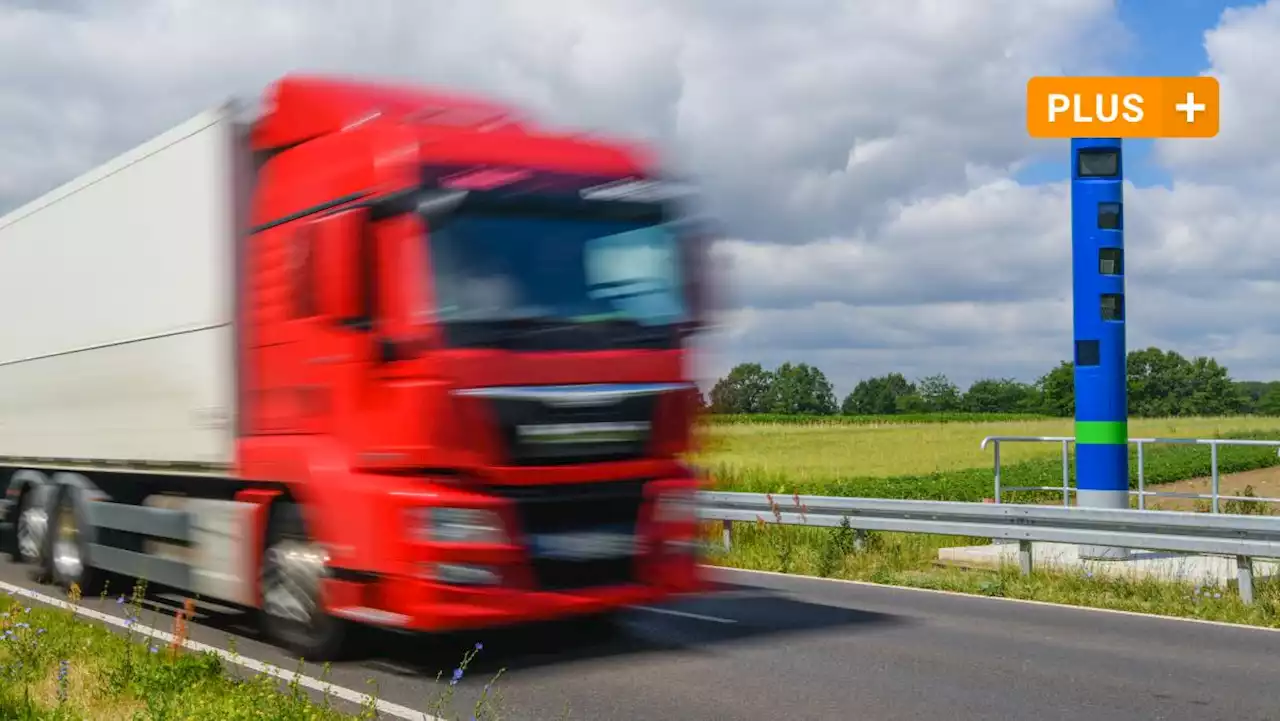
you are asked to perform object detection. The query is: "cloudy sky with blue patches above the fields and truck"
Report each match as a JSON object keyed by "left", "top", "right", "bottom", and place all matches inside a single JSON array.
[{"left": 0, "top": 0, "right": 1280, "bottom": 396}]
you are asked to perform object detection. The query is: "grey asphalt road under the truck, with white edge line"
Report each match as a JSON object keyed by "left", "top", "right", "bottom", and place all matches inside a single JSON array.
[{"left": 0, "top": 562, "right": 1280, "bottom": 721}]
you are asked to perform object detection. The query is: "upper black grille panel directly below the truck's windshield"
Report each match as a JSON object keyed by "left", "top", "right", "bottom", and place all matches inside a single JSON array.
[{"left": 488, "top": 393, "right": 658, "bottom": 466}]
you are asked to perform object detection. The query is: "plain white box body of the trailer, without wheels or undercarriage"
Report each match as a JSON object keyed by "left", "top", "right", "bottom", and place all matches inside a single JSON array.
[{"left": 0, "top": 105, "right": 239, "bottom": 469}]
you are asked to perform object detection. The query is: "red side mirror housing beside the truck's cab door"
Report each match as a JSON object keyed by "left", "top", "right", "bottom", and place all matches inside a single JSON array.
[{"left": 308, "top": 207, "right": 371, "bottom": 329}]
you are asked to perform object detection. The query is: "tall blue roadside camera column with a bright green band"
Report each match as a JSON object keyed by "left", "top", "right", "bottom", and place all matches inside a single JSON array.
[{"left": 1071, "top": 138, "right": 1129, "bottom": 558}]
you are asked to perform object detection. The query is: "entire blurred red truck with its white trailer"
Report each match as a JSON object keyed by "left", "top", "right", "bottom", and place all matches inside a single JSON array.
[{"left": 0, "top": 76, "right": 709, "bottom": 660}]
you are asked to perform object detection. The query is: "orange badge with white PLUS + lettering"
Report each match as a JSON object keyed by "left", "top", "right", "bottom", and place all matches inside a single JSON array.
[{"left": 1027, "top": 76, "right": 1219, "bottom": 138}]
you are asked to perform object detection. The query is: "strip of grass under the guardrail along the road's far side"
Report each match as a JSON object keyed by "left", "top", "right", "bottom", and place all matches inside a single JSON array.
[{"left": 707, "top": 523, "right": 1280, "bottom": 628}]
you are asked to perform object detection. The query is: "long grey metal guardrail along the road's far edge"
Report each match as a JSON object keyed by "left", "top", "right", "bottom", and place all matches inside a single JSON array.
[{"left": 698, "top": 492, "right": 1280, "bottom": 603}]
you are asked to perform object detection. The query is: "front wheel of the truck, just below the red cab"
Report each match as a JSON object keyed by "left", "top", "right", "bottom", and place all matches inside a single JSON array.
[{"left": 260, "top": 503, "right": 349, "bottom": 662}]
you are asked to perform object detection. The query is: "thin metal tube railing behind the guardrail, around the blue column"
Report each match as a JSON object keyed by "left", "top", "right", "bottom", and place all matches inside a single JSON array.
[{"left": 982, "top": 435, "right": 1280, "bottom": 514}]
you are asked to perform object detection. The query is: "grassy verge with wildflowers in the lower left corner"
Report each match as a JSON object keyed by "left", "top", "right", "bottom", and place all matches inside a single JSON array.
[{"left": 0, "top": 584, "right": 502, "bottom": 721}]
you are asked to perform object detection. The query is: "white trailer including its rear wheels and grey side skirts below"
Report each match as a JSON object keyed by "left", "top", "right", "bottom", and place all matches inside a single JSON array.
[{"left": 0, "top": 104, "right": 262, "bottom": 604}]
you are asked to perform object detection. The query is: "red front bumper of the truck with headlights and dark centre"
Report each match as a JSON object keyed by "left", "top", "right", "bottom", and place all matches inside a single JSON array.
[{"left": 325, "top": 478, "right": 707, "bottom": 631}]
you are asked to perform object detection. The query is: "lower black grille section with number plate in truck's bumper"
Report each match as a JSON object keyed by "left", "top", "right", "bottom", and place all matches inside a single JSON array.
[{"left": 489, "top": 480, "right": 646, "bottom": 590}]
